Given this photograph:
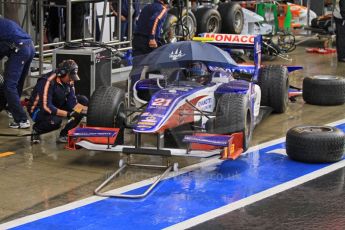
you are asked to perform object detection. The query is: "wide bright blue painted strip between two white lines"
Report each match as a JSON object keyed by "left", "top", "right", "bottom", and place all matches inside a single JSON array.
[{"left": 9, "top": 124, "right": 345, "bottom": 230}]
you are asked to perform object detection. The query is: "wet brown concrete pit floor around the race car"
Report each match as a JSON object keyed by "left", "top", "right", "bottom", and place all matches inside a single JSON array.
[{"left": 0, "top": 39, "right": 345, "bottom": 225}]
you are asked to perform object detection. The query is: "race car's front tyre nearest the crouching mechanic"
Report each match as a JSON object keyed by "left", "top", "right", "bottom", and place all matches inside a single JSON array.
[{"left": 87, "top": 86, "right": 126, "bottom": 144}]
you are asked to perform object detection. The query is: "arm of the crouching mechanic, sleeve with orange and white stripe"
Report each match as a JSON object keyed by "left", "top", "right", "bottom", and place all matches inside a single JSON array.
[{"left": 40, "top": 73, "right": 68, "bottom": 117}]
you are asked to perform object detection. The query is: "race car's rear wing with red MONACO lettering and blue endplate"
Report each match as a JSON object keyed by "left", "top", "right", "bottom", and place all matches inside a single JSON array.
[{"left": 193, "top": 33, "right": 262, "bottom": 79}]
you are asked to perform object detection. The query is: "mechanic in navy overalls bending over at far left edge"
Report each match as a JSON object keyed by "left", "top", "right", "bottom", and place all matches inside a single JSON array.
[{"left": 0, "top": 17, "right": 35, "bottom": 129}]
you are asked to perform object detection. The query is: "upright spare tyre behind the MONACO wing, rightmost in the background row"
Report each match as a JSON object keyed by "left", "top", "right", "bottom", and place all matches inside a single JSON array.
[{"left": 218, "top": 2, "right": 244, "bottom": 34}]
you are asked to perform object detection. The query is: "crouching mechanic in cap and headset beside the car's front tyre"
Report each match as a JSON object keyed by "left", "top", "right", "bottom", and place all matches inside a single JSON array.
[{"left": 27, "top": 60, "right": 88, "bottom": 143}]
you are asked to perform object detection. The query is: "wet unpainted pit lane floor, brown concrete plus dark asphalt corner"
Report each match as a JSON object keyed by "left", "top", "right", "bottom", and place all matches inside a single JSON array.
[{"left": 0, "top": 40, "right": 345, "bottom": 229}]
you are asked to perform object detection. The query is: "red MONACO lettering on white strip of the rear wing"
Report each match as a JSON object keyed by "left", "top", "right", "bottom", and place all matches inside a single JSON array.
[{"left": 203, "top": 33, "right": 255, "bottom": 45}]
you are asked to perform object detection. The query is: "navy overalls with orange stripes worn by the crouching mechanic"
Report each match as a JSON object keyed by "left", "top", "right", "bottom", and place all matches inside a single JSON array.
[{"left": 27, "top": 72, "right": 88, "bottom": 136}]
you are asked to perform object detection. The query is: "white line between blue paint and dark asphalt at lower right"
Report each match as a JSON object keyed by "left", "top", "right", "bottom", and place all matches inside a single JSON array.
[{"left": 165, "top": 160, "right": 345, "bottom": 230}]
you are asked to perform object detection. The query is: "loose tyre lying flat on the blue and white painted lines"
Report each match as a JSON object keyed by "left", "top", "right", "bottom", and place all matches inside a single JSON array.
[{"left": 286, "top": 126, "right": 345, "bottom": 163}]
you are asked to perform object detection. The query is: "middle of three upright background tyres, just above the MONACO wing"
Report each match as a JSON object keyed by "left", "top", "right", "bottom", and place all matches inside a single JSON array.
[{"left": 195, "top": 7, "right": 222, "bottom": 34}]
